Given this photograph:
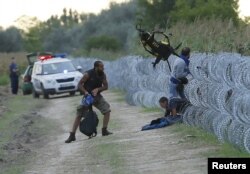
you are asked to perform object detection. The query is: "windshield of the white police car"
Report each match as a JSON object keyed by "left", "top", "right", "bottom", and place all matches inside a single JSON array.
[{"left": 42, "top": 62, "right": 76, "bottom": 74}]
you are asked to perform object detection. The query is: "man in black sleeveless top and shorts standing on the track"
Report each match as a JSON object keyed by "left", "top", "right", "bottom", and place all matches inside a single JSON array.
[{"left": 65, "top": 61, "right": 112, "bottom": 143}]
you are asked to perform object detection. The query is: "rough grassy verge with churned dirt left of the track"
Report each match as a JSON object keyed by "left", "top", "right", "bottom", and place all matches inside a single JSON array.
[{"left": 0, "top": 87, "right": 57, "bottom": 174}]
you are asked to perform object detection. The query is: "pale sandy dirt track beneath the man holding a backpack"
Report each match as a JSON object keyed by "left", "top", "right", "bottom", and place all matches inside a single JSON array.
[{"left": 25, "top": 92, "right": 212, "bottom": 174}]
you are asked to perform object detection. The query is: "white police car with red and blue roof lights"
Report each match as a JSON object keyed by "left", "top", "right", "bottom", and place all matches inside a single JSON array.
[{"left": 31, "top": 55, "right": 82, "bottom": 99}]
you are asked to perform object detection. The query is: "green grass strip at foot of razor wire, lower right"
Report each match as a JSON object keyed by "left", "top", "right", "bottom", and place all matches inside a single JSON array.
[{"left": 173, "top": 124, "right": 250, "bottom": 157}]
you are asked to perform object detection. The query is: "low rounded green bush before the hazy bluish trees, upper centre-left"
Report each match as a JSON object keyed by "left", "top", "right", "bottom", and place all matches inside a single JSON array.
[{"left": 86, "top": 35, "right": 121, "bottom": 51}]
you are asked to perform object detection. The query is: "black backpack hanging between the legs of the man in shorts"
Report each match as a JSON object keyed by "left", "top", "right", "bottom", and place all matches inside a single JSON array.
[{"left": 79, "top": 106, "right": 99, "bottom": 138}]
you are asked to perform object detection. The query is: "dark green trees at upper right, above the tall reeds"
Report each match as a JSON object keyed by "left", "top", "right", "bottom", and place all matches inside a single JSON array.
[{"left": 138, "top": 0, "right": 239, "bottom": 28}]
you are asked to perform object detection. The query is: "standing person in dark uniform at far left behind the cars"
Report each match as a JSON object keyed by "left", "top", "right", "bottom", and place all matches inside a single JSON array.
[{"left": 9, "top": 57, "right": 19, "bottom": 95}]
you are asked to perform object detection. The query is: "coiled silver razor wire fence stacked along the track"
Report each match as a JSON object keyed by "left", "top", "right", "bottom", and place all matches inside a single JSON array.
[{"left": 74, "top": 53, "right": 250, "bottom": 153}]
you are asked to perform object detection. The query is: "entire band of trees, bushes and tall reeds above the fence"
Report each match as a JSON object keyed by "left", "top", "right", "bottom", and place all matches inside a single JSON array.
[{"left": 0, "top": 0, "right": 250, "bottom": 55}]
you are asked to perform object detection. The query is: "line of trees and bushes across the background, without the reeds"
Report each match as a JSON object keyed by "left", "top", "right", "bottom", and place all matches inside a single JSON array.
[{"left": 0, "top": 0, "right": 244, "bottom": 54}]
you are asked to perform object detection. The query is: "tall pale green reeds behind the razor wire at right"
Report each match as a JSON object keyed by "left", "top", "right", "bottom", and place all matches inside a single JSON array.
[{"left": 167, "top": 18, "right": 250, "bottom": 55}]
